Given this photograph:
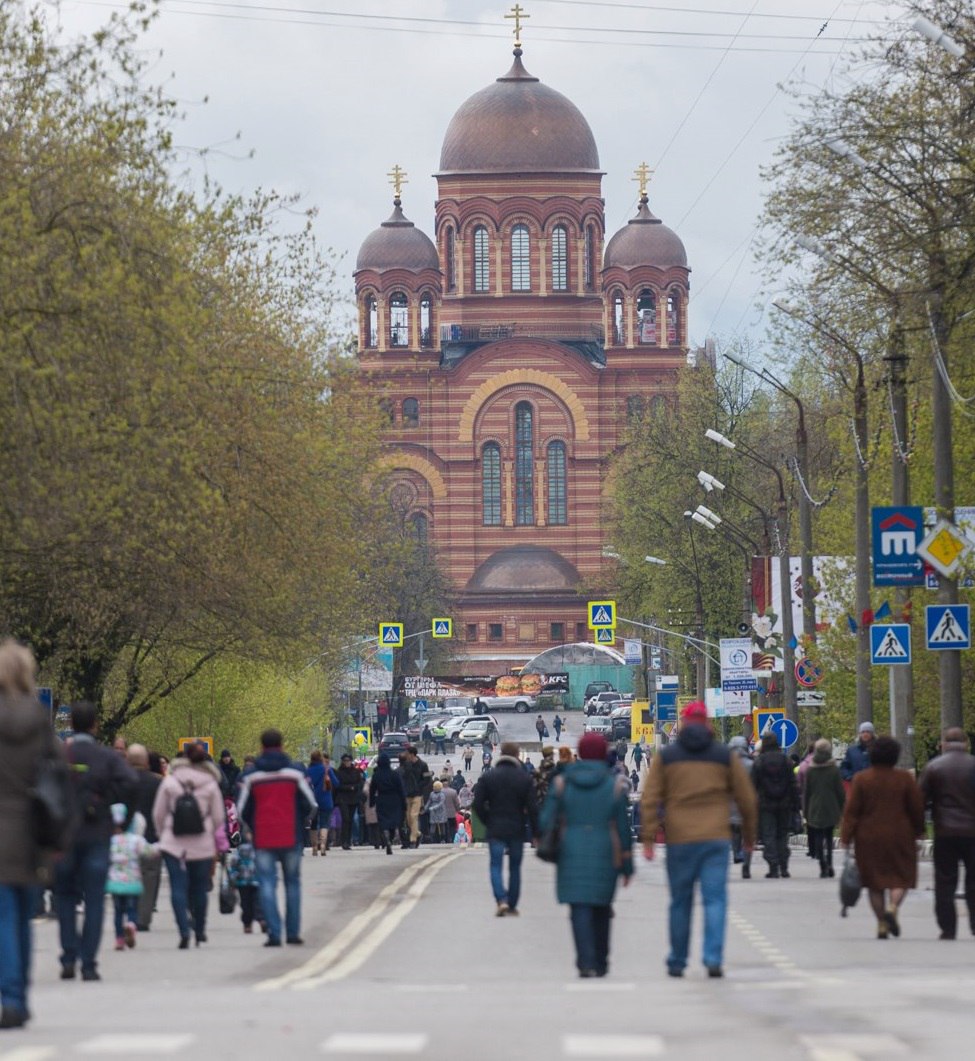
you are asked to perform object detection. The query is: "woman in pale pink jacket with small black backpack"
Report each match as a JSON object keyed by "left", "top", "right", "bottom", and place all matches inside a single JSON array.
[{"left": 153, "top": 743, "right": 226, "bottom": 951}]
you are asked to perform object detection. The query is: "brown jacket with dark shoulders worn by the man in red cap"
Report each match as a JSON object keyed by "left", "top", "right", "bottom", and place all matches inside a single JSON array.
[{"left": 640, "top": 725, "right": 758, "bottom": 846}]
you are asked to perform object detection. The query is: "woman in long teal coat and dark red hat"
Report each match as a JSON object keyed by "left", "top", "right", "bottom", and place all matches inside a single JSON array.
[{"left": 541, "top": 733, "right": 633, "bottom": 977}]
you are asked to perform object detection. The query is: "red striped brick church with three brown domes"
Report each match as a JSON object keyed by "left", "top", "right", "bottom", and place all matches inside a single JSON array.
[{"left": 354, "top": 35, "right": 690, "bottom": 674}]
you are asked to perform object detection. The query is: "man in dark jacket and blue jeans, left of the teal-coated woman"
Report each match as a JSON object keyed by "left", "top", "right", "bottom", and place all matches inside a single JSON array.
[{"left": 474, "top": 742, "right": 538, "bottom": 918}]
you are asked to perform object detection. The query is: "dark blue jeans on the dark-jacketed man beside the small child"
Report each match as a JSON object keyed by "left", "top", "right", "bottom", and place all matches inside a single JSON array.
[{"left": 54, "top": 840, "right": 108, "bottom": 972}]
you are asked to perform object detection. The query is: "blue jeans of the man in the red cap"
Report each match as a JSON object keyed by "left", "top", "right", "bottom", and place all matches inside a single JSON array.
[{"left": 667, "top": 840, "right": 729, "bottom": 969}]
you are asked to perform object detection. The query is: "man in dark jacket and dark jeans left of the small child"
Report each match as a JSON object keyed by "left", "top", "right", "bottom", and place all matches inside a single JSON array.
[{"left": 54, "top": 700, "right": 137, "bottom": 980}]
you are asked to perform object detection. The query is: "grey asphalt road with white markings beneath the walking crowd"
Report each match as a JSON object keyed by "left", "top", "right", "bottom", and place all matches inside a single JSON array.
[{"left": 15, "top": 819, "right": 975, "bottom": 1061}]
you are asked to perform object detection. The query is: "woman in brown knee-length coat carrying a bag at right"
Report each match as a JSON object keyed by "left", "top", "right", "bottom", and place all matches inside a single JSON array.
[{"left": 840, "top": 736, "right": 924, "bottom": 939}]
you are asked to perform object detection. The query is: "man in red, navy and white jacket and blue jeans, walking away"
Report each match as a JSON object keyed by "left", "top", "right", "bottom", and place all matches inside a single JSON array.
[{"left": 238, "top": 729, "right": 317, "bottom": 946}]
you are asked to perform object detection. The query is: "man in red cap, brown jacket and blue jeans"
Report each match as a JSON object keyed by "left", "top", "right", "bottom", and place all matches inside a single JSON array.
[{"left": 640, "top": 700, "right": 758, "bottom": 977}]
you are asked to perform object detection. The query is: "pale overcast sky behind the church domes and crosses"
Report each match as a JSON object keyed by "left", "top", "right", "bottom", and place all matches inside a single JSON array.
[{"left": 55, "top": 0, "right": 903, "bottom": 345}]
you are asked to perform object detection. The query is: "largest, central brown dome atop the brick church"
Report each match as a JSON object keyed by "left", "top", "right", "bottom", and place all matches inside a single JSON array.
[{"left": 440, "top": 49, "right": 599, "bottom": 174}]
